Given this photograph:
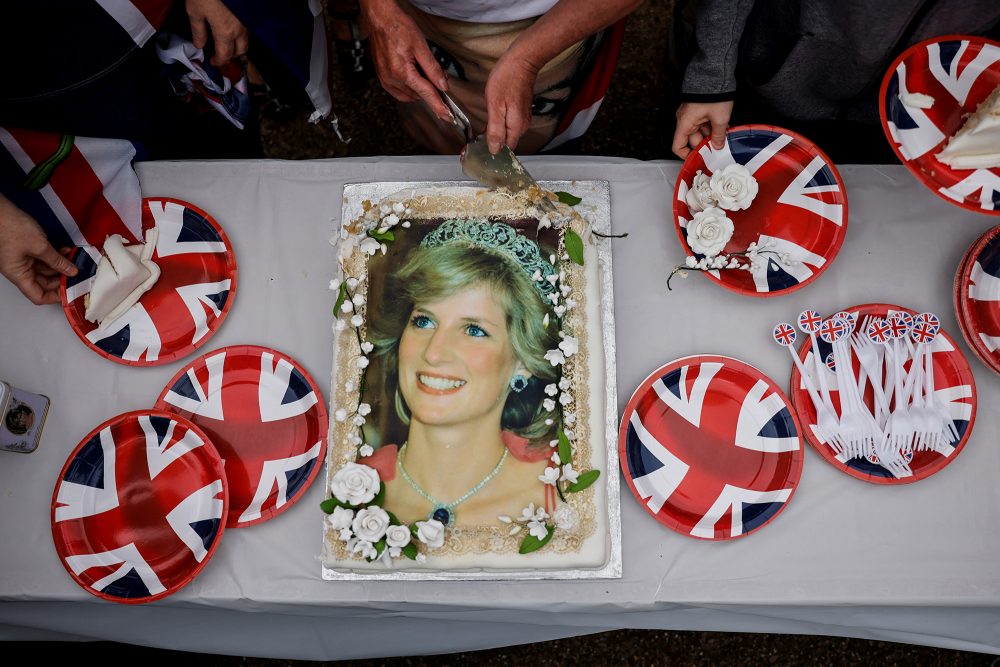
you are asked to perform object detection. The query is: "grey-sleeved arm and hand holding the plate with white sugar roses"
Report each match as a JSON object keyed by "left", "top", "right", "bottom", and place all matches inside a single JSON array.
[{"left": 671, "top": 0, "right": 754, "bottom": 158}]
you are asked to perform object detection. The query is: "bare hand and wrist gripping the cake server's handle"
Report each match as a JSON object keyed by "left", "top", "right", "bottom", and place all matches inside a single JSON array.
[{"left": 360, "top": 0, "right": 451, "bottom": 122}]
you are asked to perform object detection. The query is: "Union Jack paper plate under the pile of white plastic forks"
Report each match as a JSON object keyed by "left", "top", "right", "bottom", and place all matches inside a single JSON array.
[{"left": 788, "top": 303, "right": 978, "bottom": 484}]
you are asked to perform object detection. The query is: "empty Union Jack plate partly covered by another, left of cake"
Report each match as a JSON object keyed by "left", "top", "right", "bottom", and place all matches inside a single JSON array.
[{"left": 156, "top": 345, "right": 327, "bottom": 528}]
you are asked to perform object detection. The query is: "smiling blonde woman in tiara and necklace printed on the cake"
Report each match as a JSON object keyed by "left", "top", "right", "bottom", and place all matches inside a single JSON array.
[{"left": 361, "top": 220, "right": 559, "bottom": 527}]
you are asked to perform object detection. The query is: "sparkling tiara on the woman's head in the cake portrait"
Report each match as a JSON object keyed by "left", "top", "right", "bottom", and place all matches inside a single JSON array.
[{"left": 420, "top": 220, "right": 556, "bottom": 301}]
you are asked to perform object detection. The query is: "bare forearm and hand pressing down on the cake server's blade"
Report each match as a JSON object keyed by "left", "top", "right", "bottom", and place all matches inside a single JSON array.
[{"left": 486, "top": 0, "right": 642, "bottom": 153}]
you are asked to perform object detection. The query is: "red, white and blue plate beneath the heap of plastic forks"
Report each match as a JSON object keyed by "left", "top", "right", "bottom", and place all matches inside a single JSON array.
[{"left": 790, "top": 304, "right": 977, "bottom": 484}]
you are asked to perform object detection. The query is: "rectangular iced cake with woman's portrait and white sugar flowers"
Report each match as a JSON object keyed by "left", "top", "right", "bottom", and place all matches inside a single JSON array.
[{"left": 322, "top": 183, "right": 620, "bottom": 579}]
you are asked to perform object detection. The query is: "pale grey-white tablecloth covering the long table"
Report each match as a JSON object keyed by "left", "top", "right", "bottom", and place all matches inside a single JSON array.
[{"left": 0, "top": 157, "right": 1000, "bottom": 659}]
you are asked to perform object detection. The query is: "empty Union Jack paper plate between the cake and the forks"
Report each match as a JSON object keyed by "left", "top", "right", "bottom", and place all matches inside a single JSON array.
[{"left": 618, "top": 355, "right": 803, "bottom": 540}]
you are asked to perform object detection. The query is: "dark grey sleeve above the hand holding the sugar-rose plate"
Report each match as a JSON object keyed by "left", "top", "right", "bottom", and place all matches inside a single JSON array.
[{"left": 681, "top": 0, "right": 766, "bottom": 101}]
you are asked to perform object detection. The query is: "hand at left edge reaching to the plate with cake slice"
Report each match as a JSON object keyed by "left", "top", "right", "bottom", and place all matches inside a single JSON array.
[{"left": 0, "top": 195, "right": 77, "bottom": 305}]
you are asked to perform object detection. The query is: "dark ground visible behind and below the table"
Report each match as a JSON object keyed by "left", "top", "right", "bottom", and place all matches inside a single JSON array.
[{"left": 31, "top": 0, "right": 1000, "bottom": 667}]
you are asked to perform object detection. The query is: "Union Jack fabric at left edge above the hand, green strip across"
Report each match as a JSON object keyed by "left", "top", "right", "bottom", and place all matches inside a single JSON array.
[{"left": 0, "top": 127, "right": 142, "bottom": 248}]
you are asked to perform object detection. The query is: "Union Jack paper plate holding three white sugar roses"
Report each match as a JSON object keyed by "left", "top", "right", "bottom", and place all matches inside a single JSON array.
[{"left": 674, "top": 125, "right": 847, "bottom": 296}]
